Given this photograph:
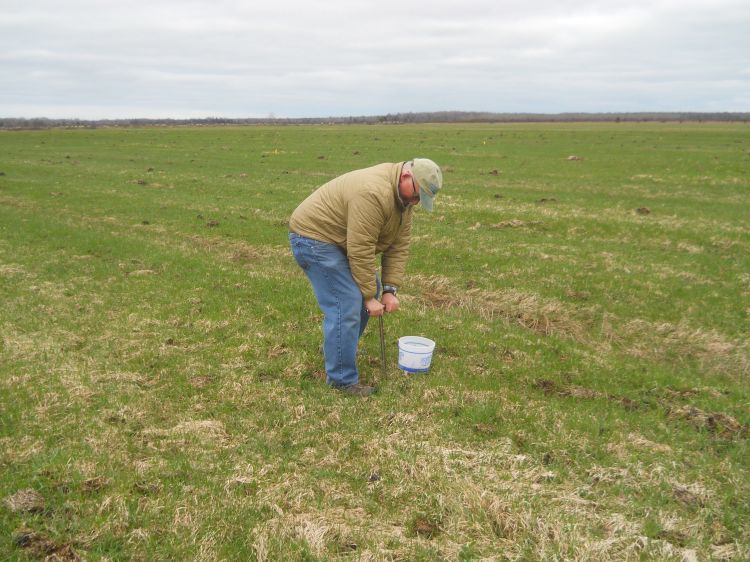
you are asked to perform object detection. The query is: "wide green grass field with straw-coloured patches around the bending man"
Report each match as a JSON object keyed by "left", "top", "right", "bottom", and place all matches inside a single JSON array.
[{"left": 0, "top": 123, "right": 750, "bottom": 561}]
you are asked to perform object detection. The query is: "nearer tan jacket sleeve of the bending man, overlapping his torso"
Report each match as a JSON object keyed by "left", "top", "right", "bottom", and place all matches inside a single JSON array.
[{"left": 346, "top": 192, "right": 385, "bottom": 300}]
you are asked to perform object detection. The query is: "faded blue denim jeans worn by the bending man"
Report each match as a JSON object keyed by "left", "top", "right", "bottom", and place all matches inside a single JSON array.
[{"left": 289, "top": 232, "right": 380, "bottom": 386}]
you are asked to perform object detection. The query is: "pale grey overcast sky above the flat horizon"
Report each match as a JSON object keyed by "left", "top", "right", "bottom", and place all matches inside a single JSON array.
[{"left": 0, "top": 0, "right": 750, "bottom": 119}]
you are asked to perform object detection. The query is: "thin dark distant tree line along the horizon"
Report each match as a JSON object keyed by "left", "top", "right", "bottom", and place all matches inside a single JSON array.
[{"left": 0, "top": 111, "right": 750, "bottom": 129}]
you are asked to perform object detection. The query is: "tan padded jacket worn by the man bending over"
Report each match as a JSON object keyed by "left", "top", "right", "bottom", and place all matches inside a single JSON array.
[{"left": 289, "top": 162, "right": 413, "bottom": 300}]
